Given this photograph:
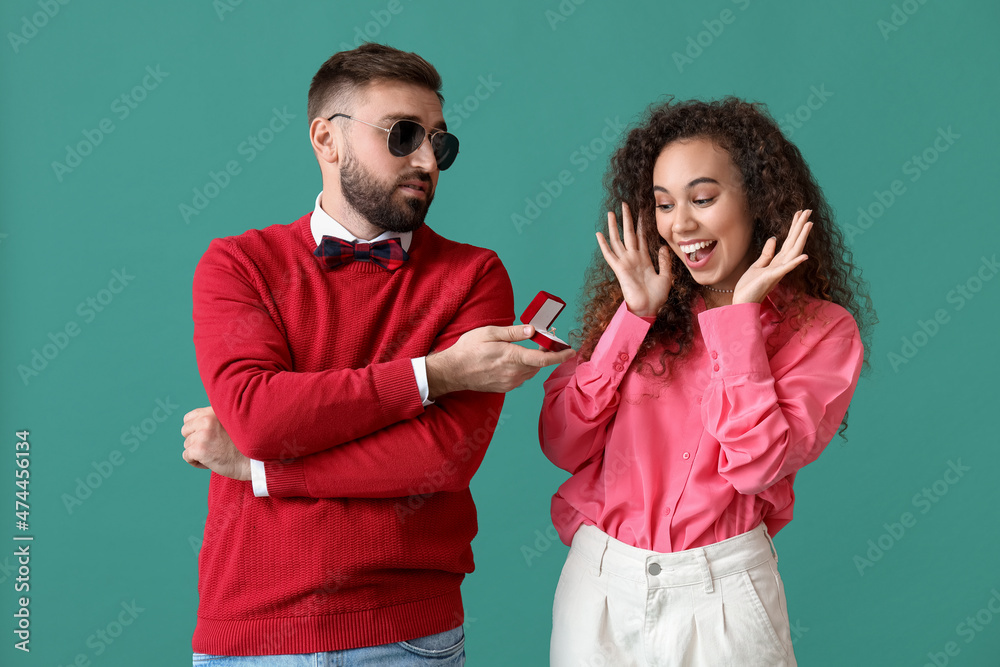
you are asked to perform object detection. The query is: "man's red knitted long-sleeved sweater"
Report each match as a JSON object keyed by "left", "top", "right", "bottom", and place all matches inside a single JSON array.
[{"left": 193, "top": 214, "right": 514, "bottom": 655}]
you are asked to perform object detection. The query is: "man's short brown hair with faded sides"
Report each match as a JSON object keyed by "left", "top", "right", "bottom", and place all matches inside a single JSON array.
[{"left": 307, "top": 42, "right": 444, "bottom": 123}]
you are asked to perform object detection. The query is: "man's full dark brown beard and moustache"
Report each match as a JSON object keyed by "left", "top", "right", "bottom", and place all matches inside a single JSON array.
[{"left": 340, "top": 149, "right": 434, "bottom": 233}]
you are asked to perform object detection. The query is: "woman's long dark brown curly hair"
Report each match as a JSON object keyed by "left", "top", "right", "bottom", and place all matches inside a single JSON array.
[{"left": 572, "top": 96, "right": 877, "bottom": 434}]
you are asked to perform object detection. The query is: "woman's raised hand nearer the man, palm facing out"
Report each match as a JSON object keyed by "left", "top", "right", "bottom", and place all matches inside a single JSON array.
[{"left": 597, "top": 202, "right": 673, "bottom": 317}]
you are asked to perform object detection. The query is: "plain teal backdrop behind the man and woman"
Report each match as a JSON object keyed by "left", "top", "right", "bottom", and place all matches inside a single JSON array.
[{"left": 0, "top": 0, "right": 1000, "bottom": 666}]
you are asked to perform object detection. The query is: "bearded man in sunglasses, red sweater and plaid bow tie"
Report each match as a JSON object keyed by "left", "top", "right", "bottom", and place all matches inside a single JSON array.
[{"left": 181, "top": 44, "right": 573, "bottom": 665}]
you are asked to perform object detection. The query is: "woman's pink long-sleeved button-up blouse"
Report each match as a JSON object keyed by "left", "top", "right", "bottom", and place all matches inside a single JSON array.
[{"left": 538, "top": 286, "right": 864, "bottom": 552}]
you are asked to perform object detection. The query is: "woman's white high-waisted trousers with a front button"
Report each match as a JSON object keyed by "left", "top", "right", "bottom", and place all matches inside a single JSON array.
[{"left": 550, "top": 524, "right": 796, "bottom": 667}]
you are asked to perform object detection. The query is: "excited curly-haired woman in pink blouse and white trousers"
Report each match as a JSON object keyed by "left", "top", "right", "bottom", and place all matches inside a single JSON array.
[{"left": 539, "top": 98, "right": 873, "bottom": 667}]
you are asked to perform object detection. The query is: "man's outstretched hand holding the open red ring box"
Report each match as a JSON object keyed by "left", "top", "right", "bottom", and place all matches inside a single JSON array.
[{"left": 427, "top": 325, "right": 576, "bottom": 400}]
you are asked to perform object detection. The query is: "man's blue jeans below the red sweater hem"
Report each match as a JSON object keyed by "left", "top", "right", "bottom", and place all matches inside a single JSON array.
[{"left": 193, "top": 625, "right": 465, "bottom": 667}]
